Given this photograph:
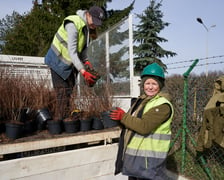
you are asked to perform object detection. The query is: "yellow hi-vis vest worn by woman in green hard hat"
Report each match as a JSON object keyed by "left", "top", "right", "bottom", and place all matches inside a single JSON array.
[{"left": 126, "top": 96, "right": 173, "bottom": 158}]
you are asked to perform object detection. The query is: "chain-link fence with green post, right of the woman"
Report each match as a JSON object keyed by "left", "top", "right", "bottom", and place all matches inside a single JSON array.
[{"left": 166, "top": 70, "right": 224, "bottom": 180}]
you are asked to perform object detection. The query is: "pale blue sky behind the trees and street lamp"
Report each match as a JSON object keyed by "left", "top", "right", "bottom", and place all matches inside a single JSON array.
[{"left": 0, "top": 0, "right": 224, "bottom": 75}]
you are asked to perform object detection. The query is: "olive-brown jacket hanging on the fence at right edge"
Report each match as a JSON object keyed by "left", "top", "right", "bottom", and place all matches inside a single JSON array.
[{"left": 196, "top": 76, "right": 224, "bottom": 151}]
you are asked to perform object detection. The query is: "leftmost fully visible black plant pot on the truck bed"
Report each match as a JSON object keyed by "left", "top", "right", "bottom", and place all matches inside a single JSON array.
[{"left": 5, "top": 123, "right": 23, "bottom": 139}]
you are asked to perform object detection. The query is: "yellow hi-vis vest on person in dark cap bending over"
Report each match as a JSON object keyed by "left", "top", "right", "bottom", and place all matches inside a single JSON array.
[{"left": 51, "top": 15, "right": 86, "bottom": 65}]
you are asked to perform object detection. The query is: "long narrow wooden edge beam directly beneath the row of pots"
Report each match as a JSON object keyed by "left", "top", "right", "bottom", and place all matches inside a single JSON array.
[{"left": 0, "top": 128, "right": 120, "bottom": 155}]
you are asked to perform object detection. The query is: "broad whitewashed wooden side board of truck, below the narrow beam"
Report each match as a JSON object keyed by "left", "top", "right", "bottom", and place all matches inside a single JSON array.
[{"left": 0, "top": 143, "right": 124, "bottom": 180}]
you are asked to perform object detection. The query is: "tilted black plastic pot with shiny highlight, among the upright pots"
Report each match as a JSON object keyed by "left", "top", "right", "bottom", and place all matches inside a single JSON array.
[{"left": 36, "top": 108, "right": 52, "bottom": 130}]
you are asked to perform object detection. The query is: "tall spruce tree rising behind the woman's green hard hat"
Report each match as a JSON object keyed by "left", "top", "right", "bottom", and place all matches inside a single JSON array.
[{"left": 134, "top": 0, "right": 176, "bottom": 74}]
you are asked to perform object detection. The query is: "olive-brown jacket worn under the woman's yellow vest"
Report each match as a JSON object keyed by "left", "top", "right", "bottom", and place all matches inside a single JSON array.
[{"left": 115, "top": 93, "right": 172, "bottom": 174}]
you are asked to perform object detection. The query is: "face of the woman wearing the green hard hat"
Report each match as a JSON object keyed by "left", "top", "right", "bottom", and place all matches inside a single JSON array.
[{"left": 143, "top": 78, "right": 160, "bottom": 96}]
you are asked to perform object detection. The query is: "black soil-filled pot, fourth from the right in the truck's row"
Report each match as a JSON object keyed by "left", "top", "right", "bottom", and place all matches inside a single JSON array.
[{"left": 63, "top": 117, "right": 80, "bottom": 133}]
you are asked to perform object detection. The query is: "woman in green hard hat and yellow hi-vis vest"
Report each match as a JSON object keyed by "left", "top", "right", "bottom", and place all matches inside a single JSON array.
[{"left": 110, "top": 63, "right": 174, "bottom": 180}]
